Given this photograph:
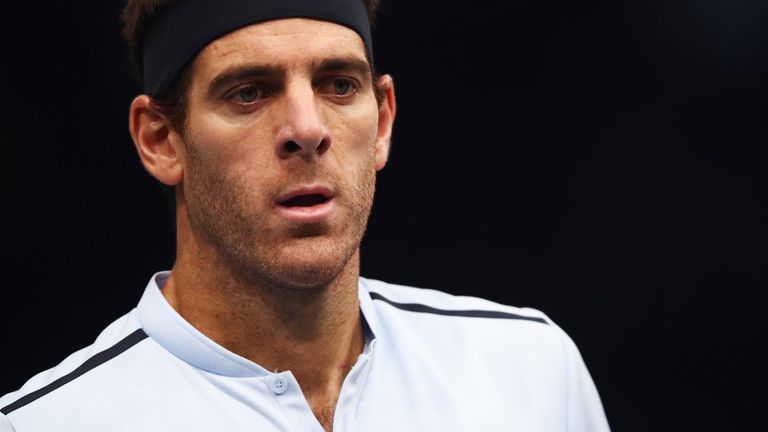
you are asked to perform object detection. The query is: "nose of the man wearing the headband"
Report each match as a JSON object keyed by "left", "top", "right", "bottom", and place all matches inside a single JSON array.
[{"left": 276, "top": 84, "right": 331, "bottom": 159}]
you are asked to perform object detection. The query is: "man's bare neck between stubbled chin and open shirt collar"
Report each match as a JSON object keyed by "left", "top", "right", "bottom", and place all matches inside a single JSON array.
[{"left": 162, "top": 230, "right": 364, "bottom": 429}]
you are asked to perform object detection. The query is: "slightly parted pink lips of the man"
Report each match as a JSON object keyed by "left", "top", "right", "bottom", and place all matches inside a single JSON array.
[{"left": 274, "top": 185, "right": 335, "bottom": 223}]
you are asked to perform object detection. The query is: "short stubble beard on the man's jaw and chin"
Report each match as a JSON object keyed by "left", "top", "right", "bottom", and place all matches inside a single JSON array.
[{"left": 178, "top": 145, "right": 376, "bottom": 291}]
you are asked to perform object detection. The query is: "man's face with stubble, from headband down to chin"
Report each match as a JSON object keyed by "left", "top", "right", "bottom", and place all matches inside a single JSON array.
[{"left": 175, "top": 19, "right": 388, "bottom": 288}]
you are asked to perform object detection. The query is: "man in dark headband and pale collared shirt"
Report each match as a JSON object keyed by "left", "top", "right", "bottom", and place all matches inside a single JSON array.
[{"left": 0, "top": 0, "right": 608, "bottom": 432}]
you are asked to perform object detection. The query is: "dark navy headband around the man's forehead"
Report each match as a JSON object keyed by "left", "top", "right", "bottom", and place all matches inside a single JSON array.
[{"left": 142, "top": 0, "right": 373, "bottom": 98}]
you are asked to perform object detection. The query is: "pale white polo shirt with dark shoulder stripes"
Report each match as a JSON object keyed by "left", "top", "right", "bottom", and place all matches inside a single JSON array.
[{"left": 0, "top": 272, "right": 608, "bottom": 432}]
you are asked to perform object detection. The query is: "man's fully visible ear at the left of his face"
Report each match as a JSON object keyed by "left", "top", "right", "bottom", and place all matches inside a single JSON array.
[{"left": 129, "top": 95, "right": 184, "bottom": 186}]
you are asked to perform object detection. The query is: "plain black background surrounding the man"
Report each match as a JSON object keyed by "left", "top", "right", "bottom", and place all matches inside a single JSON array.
[{"left": 0, "top": 0, "right": 768, "bottom": 431}]
